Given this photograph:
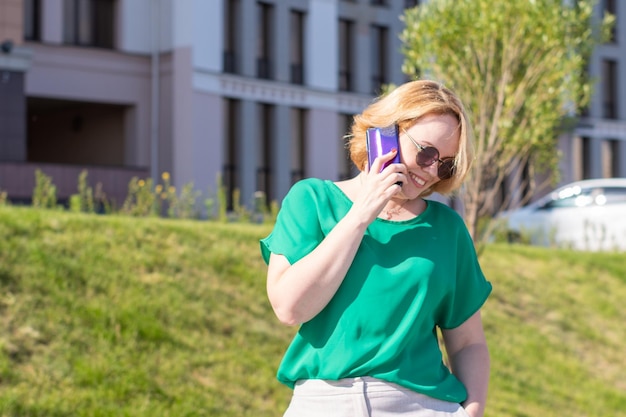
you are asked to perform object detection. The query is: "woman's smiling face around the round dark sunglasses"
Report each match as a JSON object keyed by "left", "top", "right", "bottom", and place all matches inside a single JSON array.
[{"left": 399, "top": 114, "right": 460, "bottom": 199}]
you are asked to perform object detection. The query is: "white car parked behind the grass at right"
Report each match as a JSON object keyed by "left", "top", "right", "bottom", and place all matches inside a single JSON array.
[{"left": 500, "top": 178, "right": 626, "bottom": 251}]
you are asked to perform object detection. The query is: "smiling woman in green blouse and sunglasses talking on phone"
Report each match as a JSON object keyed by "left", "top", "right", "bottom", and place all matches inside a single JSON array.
[{"left": 261, "top": 80, "right": 491, "bottom": 417}]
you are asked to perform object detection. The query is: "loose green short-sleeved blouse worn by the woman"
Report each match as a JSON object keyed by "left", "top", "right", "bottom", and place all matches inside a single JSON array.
[{"left": 261, "top": 179, "right": 491, "bottom": 402}]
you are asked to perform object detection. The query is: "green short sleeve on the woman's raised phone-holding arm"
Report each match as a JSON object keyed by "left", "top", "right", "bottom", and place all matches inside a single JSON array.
[{"left": 260, "top": 179, "right": 328, "bottom": 264}]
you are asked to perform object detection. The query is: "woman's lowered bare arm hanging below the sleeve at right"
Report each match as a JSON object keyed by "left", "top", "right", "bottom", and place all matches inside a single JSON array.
[{"left": 442, "top": 311, "right": 489, "bottom": 417}]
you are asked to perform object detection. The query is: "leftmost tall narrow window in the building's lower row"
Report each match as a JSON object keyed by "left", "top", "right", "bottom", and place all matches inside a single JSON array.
[{"left": 222, "top": 99, "right": 241, "bottom": 210}]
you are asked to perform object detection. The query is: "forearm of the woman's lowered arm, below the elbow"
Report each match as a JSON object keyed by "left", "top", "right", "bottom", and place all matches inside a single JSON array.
[{"left": 450, "top": 343, "right": 490, "bottom": 417}]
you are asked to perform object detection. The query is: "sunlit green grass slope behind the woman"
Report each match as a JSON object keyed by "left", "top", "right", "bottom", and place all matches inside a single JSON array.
[{"left": 0, "top": 207, "right": 626, "bottom": 417}]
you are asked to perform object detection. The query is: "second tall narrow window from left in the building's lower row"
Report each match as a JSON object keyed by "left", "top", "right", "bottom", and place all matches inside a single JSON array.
[{"left": 256, "top": 104, "right": 275, "bottom": 201}]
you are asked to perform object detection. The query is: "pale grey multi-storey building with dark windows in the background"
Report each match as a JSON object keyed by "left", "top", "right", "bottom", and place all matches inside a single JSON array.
[{"left": 0, "top": 0, "right": 626, "bottom": 211}]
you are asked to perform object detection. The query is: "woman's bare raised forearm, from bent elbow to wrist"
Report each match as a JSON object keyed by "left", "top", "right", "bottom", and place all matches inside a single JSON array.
[{"left": 267, "top": 208, "right": 369, "bottom": 325}]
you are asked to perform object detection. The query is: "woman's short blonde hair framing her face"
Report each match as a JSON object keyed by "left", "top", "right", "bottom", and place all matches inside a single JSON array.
[{"left": 348, "top": 80, "right": 474, "bottom": 196}]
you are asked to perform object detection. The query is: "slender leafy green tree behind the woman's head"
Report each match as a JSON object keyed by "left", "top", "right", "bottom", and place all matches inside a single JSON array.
[{"left": 401, "top": 0, "right": 613, "bottom": 242}]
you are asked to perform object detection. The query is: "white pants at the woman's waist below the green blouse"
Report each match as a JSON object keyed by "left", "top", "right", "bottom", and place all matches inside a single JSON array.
[{"left": 284, "top": 377, "right": 468, "bottom": 417}]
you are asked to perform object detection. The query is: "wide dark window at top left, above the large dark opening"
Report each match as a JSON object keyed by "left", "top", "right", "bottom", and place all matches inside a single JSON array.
[{"left": 64, "top": 0, "right": 114, "bottom": 48}]
